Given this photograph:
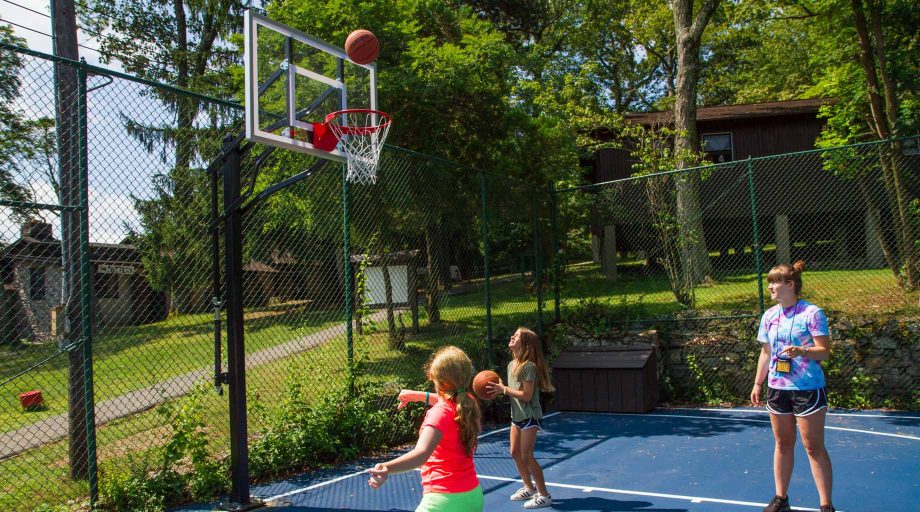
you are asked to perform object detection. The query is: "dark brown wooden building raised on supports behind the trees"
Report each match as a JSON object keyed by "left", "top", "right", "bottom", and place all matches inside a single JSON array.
[{"left": 592, "top": 99, "right": 884, "bottom": 278}]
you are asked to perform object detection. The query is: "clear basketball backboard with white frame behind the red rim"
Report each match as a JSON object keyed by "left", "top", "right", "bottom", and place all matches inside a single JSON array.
[{"left": 244, "top": 10, "right": 377, "bottom": 162}]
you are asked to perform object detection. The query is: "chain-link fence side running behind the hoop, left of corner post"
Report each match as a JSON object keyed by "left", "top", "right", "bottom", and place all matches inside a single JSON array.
[{"left": 0, "top": 46, "right": 545, "bottom": 510}]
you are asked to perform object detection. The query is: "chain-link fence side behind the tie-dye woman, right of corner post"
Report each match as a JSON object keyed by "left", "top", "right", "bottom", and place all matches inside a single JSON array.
[{"left": 555, "top": 138, "right": 920, "bottom": 407}]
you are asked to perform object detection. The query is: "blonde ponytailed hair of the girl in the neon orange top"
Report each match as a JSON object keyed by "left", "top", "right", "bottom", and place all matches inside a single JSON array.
[{"left": 425, "top": 345, "right": 482, "bottom": 457}]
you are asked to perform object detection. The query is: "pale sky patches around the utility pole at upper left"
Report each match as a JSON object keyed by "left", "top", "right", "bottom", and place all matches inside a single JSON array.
[{"left": 0, "top": 0, "right": 174, "bottom": 243}]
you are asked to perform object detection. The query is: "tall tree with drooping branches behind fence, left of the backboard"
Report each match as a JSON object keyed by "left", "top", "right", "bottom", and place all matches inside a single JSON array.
[{"left": 81, "top": 0, "right": 251, "bottom": 312}]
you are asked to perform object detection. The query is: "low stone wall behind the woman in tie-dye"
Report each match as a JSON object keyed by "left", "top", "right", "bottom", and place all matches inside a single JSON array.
[{"left": 563, "top": 317, "right": 920, "bottom": 410}]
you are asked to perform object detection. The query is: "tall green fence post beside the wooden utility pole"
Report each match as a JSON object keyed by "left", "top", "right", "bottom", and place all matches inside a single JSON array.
[{"left": 77, "top": 59, "right": 99, "bottom": 509}]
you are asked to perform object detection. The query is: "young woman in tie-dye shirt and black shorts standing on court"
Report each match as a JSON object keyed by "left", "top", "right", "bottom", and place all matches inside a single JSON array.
[{"left": 751, "top": 260, "right": 834, "bottom": 512}]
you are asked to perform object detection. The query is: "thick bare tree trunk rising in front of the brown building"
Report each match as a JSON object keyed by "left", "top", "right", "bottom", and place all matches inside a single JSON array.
[{"left": 669, "top": 0, "right": 719, "bottom": 282}]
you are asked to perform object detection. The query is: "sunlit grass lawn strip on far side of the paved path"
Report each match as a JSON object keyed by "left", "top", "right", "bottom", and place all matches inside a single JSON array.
[{"left": 0, "top": 304, "right": 343, "bottom": 431}]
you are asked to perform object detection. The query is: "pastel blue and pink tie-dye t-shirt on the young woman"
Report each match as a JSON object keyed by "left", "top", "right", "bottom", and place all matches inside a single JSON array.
[{"left": 757, "top": 300, "right": 830, "bottom": 390}]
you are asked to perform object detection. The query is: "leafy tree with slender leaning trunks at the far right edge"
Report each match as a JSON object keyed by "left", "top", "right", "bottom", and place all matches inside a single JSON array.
[{"left": 815, "top": 0, "right": 920, "bottom": 288}]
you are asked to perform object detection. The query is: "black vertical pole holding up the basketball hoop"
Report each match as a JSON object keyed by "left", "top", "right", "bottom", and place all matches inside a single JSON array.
[{"left": 222, "top": 137, "right": 262, "bottom": 510}]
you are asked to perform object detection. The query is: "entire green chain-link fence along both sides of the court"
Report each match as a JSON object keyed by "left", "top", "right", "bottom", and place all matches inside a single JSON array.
[{"left": 0, "top": 42, "right": 920, "bottom": 510}]
